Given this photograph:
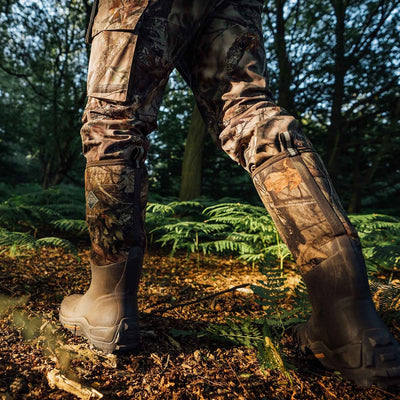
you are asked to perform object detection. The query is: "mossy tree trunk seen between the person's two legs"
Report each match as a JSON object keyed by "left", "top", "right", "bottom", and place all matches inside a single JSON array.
[{"left": 179, "top": 104, "right": 207, "bottom": 201}]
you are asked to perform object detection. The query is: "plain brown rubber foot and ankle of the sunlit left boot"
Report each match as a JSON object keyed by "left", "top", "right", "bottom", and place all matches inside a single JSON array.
[{"left": 60, "top": 247, "right": 143, "bottom": 353}]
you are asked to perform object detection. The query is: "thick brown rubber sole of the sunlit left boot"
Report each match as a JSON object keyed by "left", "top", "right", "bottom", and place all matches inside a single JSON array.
[{"left": 59, "top": 313, "right": 140, "bottom": 354}]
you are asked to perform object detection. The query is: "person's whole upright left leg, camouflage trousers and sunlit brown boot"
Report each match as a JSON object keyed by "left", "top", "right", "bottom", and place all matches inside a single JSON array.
[{"left": 60, "top": 0, "right": 216, "bottom": 352}]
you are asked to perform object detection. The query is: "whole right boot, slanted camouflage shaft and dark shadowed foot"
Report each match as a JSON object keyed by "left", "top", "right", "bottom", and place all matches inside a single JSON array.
[{"left": 253, "top": 132, "right": 400, "bottom": 386}]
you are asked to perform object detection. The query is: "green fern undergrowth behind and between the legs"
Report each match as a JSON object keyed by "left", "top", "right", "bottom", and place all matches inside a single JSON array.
[{"left": 0, "top": 184, "right": 400, "bottom": 379}]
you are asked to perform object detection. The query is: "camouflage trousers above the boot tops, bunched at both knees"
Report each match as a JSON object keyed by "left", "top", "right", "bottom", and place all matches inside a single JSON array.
[{"left": 81, "top": 0, "right": 270, "bottom": 164}]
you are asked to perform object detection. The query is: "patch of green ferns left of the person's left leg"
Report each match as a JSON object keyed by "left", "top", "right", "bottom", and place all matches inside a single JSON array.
[{"left": 0, "top": 184, "right": 86, "bottom": 255}]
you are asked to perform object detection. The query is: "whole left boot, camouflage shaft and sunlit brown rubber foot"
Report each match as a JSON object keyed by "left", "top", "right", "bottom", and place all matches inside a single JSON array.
[{"left": 60, "top": 160, "right": 147, "bottom": 353}]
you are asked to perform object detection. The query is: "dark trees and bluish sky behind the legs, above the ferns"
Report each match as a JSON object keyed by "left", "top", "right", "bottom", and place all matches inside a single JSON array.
[{"left": 0, "top": 0, "right": 400, "bottom": 215}]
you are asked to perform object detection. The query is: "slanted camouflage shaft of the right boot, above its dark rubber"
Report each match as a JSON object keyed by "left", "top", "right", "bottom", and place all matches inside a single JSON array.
[{"left": 253, "top": 147, "right": 361, "bottom": 275}]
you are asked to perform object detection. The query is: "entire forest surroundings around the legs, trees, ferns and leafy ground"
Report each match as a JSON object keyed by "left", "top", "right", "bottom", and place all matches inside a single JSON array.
[{"left": 0, "top": 0, "right": 400, "bottom": 400}]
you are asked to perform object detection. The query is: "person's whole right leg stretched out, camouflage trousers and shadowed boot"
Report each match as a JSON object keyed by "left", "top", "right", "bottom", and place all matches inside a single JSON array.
[{"left": 181, "top": 0, "right": 400, "bottom": 385}]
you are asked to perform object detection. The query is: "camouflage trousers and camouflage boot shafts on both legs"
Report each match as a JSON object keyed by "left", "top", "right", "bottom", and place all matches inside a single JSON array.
[{"left": 81, "top": 0, "right": 359, "bottom": 274}]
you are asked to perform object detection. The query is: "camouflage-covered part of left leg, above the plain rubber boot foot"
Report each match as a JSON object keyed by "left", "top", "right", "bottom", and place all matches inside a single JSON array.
[{"left": 81, "top": 0, "right": 219, "bottom": 264}]
